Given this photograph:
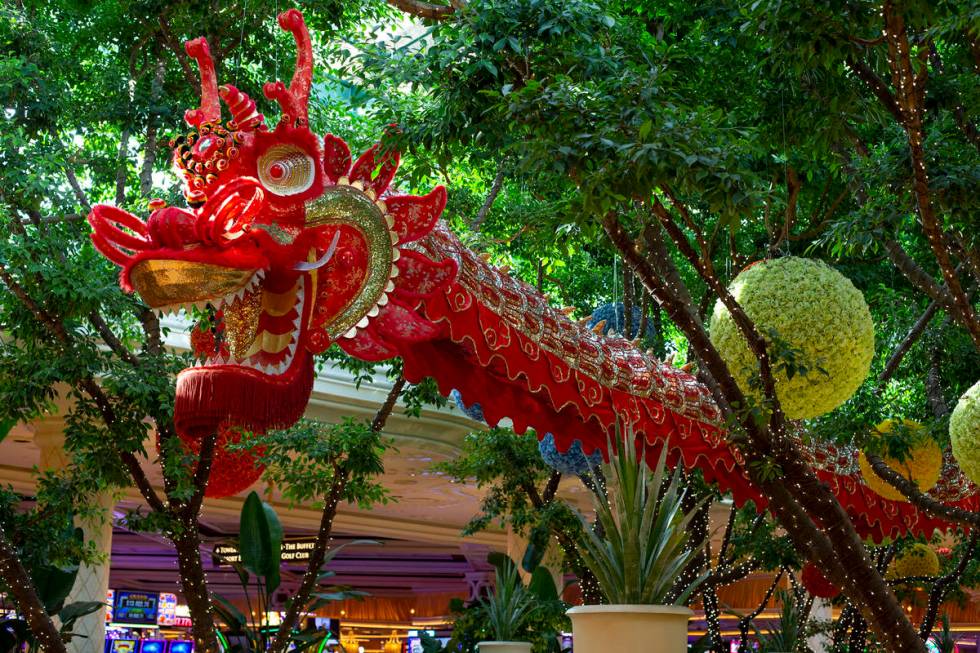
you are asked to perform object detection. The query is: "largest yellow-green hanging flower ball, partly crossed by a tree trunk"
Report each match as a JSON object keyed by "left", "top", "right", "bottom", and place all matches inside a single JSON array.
[{"left": 710, "top": 256, "right": 874, "bottom": 419}]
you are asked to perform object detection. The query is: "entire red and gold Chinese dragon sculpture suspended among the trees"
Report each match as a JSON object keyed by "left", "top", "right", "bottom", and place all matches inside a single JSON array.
[{"left": 89, "top": 10, "right": 975, "bottom": 540}]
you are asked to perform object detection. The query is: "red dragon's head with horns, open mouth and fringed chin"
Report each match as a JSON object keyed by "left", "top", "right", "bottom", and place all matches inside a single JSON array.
[{"left": 89, "top": 9, "right": 456, "bottom": 437}]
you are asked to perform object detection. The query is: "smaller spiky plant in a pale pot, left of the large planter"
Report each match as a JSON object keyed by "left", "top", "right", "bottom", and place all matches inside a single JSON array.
[{"left": 477, "top": 558, "right": 534, "bottom": 653}]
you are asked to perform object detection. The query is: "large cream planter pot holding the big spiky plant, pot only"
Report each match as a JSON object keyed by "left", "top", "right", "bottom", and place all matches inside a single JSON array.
[{"left": 568, "top": 605, "right": 694, "bottom": 653}]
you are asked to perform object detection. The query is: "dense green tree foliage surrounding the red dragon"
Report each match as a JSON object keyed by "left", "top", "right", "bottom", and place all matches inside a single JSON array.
[{"left": 0, "top": 0, "right": 980, "bottom": 648}]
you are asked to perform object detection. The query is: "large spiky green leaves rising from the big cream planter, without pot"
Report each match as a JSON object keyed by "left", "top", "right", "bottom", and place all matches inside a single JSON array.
[{"left": 581, "top": 430, "right": 706, "bottom": 605}]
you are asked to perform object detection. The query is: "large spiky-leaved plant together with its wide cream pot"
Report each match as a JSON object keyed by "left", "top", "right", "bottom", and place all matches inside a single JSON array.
[{"left": 568, "top": 433, "right": 705, "bottom": 653}]
